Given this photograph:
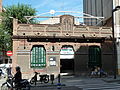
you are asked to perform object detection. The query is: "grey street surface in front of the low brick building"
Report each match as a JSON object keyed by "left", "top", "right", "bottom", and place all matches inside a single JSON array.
[{"left": 0, "top": 76, "right": 120, "bottom": 90}]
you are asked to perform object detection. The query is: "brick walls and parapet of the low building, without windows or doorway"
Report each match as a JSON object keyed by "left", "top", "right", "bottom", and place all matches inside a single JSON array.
[{"left": 12, "top": 15, "right": 113, "bottom": 78}]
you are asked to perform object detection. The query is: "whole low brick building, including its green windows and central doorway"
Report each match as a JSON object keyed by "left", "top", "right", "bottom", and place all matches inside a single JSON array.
[{"left": 12, "top": 15, "right": 114, "bottom": 78}]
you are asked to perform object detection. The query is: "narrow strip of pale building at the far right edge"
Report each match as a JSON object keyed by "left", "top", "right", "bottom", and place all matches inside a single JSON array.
[{"left": 113, "top": 0, "right": 120, "bottom": 75}]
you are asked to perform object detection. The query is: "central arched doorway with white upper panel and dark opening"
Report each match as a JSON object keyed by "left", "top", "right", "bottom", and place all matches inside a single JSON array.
[{"left": 60, "top": 45, "right": 74, "bottom": 74}]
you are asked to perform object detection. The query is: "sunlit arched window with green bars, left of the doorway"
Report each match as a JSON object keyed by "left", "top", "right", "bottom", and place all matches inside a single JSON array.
[{"left": 30, "top": 45, "right": 46, "bottom": 68}]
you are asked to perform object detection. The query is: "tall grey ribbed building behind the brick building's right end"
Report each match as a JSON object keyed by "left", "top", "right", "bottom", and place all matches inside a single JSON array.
[{"left": 83, "top": 0, "right": 113, "bottom": 26}]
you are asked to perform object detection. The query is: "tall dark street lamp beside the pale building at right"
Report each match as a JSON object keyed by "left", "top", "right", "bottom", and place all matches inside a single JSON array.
[{"left": 112, "top": 6, "right": 120, "bottom": 79}]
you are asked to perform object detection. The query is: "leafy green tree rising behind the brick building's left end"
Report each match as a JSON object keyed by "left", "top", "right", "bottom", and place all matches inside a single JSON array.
[{"left": 0, "top": 3, "right": 36, "bottom": 51}]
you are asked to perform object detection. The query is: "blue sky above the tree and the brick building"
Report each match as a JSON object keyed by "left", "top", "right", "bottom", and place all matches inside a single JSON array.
[{"left": 2, "top": 0, "right": 83, "bottom": 21}]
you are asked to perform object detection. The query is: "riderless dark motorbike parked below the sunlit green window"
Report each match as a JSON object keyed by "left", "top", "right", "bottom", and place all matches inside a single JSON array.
[{"left": 30, "top": 72, "right": 49, "bottom": 85}]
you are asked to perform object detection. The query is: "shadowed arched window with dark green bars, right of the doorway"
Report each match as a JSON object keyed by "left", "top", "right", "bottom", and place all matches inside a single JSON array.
[{"left": 88, "top": 46, "right": 102, "bottom": 68}]
